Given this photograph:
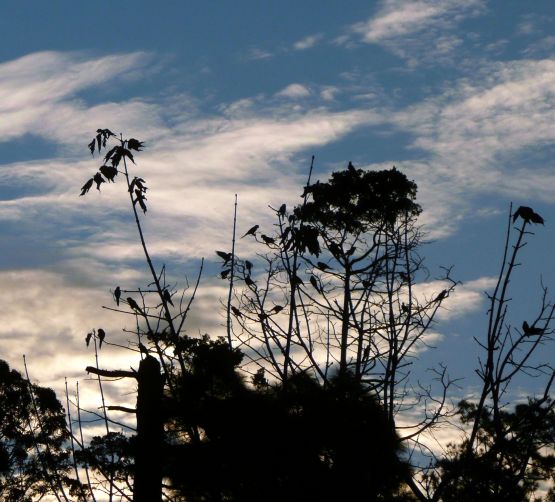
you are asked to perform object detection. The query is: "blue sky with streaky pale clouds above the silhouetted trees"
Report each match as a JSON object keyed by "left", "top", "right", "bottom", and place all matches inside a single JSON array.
[{"left": 0, "top": 0, "right": 555, "bottom": 440}]
